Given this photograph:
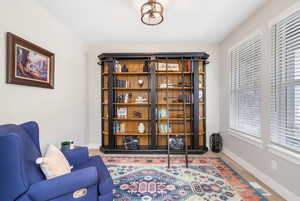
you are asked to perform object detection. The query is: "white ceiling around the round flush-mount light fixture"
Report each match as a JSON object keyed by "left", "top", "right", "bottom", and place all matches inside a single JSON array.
[{"left": 37, "top": 0, "right": 267, "bottom": 45}]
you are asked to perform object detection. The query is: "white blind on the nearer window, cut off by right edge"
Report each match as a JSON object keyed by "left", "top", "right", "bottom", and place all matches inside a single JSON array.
[{"left": 270, "top": 8, "right": 300, "bottom": 152}]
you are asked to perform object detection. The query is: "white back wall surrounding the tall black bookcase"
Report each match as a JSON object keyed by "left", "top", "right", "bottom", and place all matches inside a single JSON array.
[{"left": 88, "top": 44, "right": 219, "bottom": 146}]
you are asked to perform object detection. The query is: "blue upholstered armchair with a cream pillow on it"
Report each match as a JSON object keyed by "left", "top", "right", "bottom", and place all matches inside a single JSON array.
[{"left": 0, "top": 122, "right": 113, "bottom": 201}]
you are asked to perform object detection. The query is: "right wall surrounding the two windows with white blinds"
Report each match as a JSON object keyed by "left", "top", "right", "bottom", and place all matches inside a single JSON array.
[{"left": 220, "top": 0, "right": 300, "bottom": 201}]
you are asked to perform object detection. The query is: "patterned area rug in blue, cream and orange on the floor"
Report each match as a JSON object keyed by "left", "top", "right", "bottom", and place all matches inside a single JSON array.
[{"left": 103, "top": 156, "right": 267, "bottom": 201}]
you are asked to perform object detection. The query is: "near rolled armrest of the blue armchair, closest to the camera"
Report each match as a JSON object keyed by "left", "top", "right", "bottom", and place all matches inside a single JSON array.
[{"left": 28, "top": 167, "right": 98, "bottom": 201}]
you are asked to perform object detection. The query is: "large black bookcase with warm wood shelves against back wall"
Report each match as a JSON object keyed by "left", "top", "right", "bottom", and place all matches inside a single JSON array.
[{"left": 99, "top": 52, "right": 209, "bottom": 154}]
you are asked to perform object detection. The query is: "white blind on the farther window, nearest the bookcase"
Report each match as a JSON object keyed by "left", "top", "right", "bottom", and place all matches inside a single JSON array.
[{"left": 230, "top": 35, "right": 262, "bottom": 137}]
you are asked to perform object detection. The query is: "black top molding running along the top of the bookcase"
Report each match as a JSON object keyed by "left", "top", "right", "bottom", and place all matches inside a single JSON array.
[{"left": 98, "top": 52, "right": 209, "bottom": 61}]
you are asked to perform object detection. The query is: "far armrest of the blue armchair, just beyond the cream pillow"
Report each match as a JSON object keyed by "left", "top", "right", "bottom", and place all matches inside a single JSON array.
[{"left": 63, "top": 147, "right": 89, "bottom": 166}]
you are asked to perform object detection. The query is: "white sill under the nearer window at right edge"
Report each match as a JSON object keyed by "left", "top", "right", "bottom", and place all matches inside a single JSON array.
[{"left": 268, "top": 144, "right": 300, "bottom": 166}]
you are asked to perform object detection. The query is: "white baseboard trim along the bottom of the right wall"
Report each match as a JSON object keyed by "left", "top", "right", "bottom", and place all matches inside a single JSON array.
[{"left": 223, "top": 148, "right": 300, "bottom": 201}]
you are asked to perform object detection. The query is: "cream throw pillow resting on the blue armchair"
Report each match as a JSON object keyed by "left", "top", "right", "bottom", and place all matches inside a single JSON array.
[{"left": 36, "top": 144, "right": 71, "bottom": 179}]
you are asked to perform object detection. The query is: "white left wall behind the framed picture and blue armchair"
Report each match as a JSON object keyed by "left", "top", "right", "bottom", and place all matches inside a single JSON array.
[{"left": 0, "top": 0, "right": 87, "bottom": 151}]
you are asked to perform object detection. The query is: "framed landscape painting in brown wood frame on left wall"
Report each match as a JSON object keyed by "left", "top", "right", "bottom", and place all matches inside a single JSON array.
[{"left": 7, "top": 33, "right": 54, "bottom": 89}]
